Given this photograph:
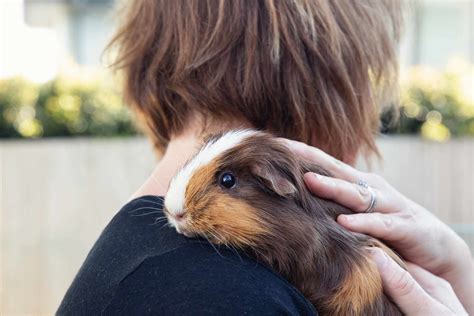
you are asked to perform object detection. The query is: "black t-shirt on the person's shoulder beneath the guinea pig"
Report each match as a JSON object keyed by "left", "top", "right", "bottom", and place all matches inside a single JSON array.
[{"left": 57, "top": 196, "right": 317, "bottom": 315}]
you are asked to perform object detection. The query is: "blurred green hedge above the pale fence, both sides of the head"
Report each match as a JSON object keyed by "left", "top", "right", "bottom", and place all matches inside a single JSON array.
[{"left": 0, "top": 61, "right": 474, "bottom": 141}]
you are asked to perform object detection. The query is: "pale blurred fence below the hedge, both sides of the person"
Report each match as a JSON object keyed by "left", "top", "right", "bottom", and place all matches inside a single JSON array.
[{"left": 0, "top": 137, "right": 474, "bottom": 315}]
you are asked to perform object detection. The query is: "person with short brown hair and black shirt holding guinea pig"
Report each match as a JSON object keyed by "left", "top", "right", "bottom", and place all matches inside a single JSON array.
[{"left": 58, "top": 0, "right": 474, "bottom": 315}]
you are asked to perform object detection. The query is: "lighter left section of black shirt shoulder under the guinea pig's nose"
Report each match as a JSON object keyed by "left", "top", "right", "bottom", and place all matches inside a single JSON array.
[{"left": 57, "top": 196, "right": 189, "bottom": 315}]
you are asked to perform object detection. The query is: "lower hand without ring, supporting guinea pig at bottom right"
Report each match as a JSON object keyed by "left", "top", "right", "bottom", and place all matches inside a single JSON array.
[{"left": 369, "top": 247, "right": 467, "bottom": 316}]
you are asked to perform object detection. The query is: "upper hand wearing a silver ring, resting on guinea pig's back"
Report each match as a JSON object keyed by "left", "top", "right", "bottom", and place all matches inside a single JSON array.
[{"left": 287, "top": 141, "right": 474, "bottom": 314}]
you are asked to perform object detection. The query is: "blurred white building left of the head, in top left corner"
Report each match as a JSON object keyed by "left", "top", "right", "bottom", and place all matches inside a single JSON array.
[{"left": 0, "top": 0, "right": 116, "bottom": 82}]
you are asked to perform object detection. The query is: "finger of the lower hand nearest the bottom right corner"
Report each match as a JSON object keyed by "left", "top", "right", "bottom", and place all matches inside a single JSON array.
[{"left": 407, "top": 263, "right": 465, "bottom": 314}]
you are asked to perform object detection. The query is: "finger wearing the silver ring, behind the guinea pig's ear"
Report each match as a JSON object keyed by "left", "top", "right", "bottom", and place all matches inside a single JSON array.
[{"left": 304, "top": 172, "right": 393, "bottom": 212}]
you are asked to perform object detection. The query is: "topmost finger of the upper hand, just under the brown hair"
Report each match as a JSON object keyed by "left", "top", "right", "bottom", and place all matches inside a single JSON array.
[{"left": 282, "top": 139, "right": 364, "bottom": 182}]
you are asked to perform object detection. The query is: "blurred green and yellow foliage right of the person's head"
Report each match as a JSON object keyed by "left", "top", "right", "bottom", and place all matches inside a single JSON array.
[{"left": 383, "top": 60, "right": 474, "bottom": 141}]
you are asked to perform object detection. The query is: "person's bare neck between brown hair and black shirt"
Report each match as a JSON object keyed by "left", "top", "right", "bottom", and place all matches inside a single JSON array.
[{"left": 131, "top": 119, "right": 245, "bottom": 199}]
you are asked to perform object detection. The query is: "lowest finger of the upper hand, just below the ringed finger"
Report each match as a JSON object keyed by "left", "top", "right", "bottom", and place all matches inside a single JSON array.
[{"left": 337, "top": 213, "right": 411, "bottom": 241}]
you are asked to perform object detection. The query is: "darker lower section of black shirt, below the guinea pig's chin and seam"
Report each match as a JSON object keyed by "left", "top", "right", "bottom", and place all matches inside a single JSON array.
[{"left": 105, "top": 242, "right": 316, "bottom": 315}]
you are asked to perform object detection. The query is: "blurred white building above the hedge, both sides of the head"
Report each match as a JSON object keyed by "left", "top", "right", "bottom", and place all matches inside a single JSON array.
[{"left": 0, "top": 0, "right": 474, "bottom": 81}]
